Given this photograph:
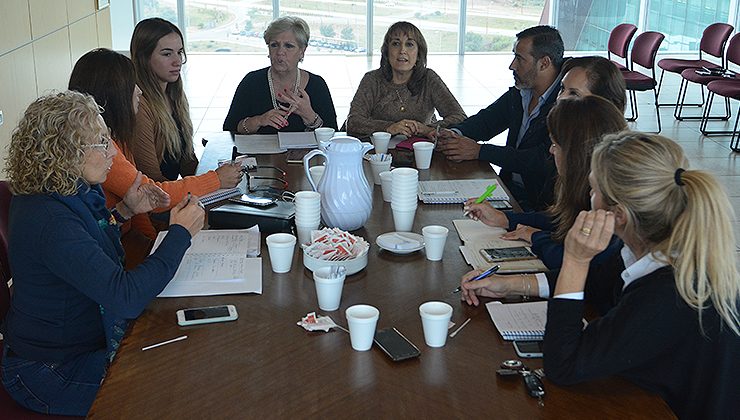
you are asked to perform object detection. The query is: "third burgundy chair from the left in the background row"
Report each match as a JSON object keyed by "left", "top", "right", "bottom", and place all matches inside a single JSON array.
[{"left": 658, "top": 23, "right": 734, "bottom": 106}]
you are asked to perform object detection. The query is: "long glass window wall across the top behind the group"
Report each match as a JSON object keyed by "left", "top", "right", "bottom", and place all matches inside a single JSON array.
[{"left": 135, "top": 0, "right": 740, "bottom": 55}]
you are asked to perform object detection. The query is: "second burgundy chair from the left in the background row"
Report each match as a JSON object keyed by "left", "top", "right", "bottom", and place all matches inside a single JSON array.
[{"left": 622, "top": 31, "right": 665, "bottom": 133}]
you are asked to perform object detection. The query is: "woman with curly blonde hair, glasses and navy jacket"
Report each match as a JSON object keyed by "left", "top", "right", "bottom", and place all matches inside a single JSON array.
[{"left": 2, "top": 91, "right": 204, "bottom": 416}]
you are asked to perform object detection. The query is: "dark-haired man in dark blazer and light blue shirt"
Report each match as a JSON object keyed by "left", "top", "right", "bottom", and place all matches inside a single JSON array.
[{"left": 437, "top": 26, "right": 564, "bottom": 210}]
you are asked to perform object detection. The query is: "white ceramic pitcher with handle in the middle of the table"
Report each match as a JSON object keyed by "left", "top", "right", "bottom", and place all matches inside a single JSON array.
[{"left": 303, "top": 136, "right": 373, "bottom": 231}]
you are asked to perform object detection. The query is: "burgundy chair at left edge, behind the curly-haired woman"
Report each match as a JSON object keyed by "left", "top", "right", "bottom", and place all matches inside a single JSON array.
[{"left": 0, "top": 181, "right": 82, "bottom": 420}]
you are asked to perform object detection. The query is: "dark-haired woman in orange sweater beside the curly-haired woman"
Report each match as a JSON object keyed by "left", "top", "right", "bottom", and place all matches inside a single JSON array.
[{"left": 69, "top": 48, "right": 242, "bottom": 267}]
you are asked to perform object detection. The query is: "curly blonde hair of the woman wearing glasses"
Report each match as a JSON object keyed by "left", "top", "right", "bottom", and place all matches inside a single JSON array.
[{"left": 5, "top": 91, "right": 105, "bottom": 195}]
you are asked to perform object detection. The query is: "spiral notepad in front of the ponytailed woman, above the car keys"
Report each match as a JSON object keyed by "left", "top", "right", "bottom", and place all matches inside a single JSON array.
[{"left": 486, "top": 300, "right": 547, "bottom": 341}]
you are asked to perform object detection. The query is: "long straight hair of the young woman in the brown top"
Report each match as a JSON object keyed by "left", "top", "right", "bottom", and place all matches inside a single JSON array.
[{"left": 131, "top": 18, "right": 194, "bottom": 161}]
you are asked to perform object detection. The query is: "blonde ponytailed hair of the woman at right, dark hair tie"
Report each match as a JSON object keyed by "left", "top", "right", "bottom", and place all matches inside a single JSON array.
[{"left": 591, "top": 132, "right": 740, "bottom": 335}]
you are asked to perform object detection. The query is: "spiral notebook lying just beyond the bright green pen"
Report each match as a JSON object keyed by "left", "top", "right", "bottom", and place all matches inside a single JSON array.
[{"left": 419, "top": 179, "right": 509, "bottom": 204}]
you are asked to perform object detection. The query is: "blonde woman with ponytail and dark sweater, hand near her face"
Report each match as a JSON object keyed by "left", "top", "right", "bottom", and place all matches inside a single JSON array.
[{"left": 463, "top": 132, "right": 740, "bottom": 419}]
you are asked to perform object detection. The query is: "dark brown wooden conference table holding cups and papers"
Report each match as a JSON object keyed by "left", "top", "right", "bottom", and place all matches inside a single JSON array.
[{"left": 89, "top": 133, "right": 673, "bottom": 419}]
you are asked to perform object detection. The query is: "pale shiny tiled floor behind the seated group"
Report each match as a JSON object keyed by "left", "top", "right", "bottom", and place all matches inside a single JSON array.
[{"left": 184, "top": 50, "right": 740, "bottom": 251}]
